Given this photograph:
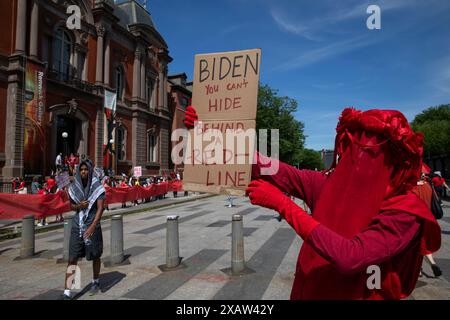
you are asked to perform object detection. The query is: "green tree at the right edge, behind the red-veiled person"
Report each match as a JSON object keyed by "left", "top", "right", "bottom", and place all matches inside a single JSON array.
[{"left": 411, "top": 104, "right": 450, "bottom": 157}]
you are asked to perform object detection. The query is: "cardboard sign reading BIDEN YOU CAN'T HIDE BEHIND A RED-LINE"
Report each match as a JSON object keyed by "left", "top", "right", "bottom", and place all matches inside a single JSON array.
[{"left": 183, "top": 49, "right": 261, "bottom": 195}]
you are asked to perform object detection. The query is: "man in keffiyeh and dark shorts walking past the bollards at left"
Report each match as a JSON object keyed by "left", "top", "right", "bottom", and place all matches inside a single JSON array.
[{"left": 63, "top": 160, "right": 105, "bottom": 299}]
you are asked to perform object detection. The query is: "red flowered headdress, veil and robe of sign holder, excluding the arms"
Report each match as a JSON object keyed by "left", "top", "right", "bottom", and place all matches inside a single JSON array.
[{"left": 291, "top": 108, "right": 440, "bottom": 299}]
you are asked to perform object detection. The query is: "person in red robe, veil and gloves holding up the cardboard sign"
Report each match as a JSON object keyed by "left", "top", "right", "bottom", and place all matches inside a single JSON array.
[{"left": 185, "top": 107, "right": 441, "bottom": 299}]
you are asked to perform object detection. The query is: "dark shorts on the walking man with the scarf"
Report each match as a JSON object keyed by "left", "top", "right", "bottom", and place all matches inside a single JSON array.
[{"left": 69, "top": 214, "right": 103, "bottom": 261}]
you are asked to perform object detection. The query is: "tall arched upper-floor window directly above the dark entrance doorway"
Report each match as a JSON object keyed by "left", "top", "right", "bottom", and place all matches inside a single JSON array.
[{"left": 52, "top": 29, "right": 72, "bottom": 81}]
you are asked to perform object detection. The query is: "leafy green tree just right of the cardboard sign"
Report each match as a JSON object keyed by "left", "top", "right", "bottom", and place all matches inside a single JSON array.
[{"left": 256, "top": 85, "right": 305, "bottom": 165}]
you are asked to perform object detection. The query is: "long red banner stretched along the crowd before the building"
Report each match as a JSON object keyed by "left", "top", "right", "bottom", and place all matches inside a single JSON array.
[{"left": 0, "top": 181, "right": 183, "bottom": 220}]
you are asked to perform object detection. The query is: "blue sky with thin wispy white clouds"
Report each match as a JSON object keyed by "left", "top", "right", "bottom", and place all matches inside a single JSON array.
[{"left": 138, "top": 0, "right": 450, "bottom": 150}]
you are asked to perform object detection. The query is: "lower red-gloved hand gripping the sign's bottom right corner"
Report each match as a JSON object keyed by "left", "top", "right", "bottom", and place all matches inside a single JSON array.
[{"left": 245, "top": 179, "right": 289, "bottom": 211}]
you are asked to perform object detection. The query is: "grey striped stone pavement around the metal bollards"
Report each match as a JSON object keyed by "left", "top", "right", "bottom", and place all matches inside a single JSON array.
[{"left": 0, "top": 196, "right": 450, "bottom": 300}]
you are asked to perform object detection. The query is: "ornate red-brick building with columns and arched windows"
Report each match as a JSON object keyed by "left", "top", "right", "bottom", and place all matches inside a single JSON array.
[{"left": 0, "top": 0, "right": 173, "bottom": 190}]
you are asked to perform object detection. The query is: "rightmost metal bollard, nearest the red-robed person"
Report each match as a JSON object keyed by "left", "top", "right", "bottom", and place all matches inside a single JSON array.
[{"left": 231, "top": 214, "right": 245, "bottom": 274}]
